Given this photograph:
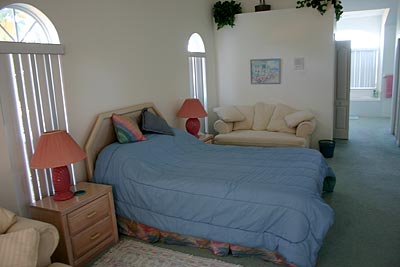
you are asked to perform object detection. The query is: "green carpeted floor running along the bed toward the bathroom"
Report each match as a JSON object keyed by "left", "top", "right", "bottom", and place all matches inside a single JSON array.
[{"left": 89, "top": 118, "right": 400, "bottom": 267}]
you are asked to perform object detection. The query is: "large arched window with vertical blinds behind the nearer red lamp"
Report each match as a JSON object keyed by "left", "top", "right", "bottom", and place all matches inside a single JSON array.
[{"left": 0, "top": 4, "right": 67, "bottom": 205}]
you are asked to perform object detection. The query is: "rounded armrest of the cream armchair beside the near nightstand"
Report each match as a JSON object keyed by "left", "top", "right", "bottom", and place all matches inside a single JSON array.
[{"left": 7, "top": 217, "right": 59, "bottom": 267}]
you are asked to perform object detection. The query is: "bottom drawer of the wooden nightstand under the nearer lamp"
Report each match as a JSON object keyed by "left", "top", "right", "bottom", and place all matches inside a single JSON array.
[{"left": 72, "top": 216, "right": 113, "bottom": 258}]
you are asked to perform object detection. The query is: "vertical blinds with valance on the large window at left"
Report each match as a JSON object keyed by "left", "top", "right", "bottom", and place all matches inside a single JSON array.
[{"left": 0, "top": 43, "right": 66, "bottom": 201}]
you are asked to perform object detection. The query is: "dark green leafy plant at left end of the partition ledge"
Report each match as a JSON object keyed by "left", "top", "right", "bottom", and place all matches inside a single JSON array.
[{"left": 213, "top": 0, "right": 242, "bottom": 30}]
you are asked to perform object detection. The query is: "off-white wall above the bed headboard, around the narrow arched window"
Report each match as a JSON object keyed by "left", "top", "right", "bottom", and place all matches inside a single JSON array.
[{"left": 0, "top": 0, "right": 218, "bottom": 215}]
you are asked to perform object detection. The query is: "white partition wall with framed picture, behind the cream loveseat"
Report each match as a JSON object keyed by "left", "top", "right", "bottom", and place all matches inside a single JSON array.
[{"left": 216, "top": 8, "right": 334, "bottom": 147}]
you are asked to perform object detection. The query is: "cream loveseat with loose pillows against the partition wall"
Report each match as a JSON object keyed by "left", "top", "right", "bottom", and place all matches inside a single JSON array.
[{"left": 214, "top": 103, "right": 316, "bottom": 147}]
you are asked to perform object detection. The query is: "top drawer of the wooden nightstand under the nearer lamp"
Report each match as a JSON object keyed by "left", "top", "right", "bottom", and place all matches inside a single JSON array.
[{"left": 68, "top": 196, "right": 110, "bottom": 236}]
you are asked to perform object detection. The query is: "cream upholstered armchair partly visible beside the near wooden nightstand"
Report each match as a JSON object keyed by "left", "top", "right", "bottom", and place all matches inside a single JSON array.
[{"left": 0, "top": 207, "right": 69, "bottom": 267}]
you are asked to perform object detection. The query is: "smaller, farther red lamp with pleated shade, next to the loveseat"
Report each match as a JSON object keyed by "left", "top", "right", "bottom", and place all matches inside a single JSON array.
[{"left": 176, "top": 98, "right": 207, "bottom": 138}]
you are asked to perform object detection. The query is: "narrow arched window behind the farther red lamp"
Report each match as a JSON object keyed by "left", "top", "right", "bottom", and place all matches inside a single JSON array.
[{"left": 188, "top": 33, "right": 208, "bottom": 133}]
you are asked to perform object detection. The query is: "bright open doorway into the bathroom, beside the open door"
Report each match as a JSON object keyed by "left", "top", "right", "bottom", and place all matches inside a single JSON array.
[{"left": 334, "top": 9, "right": 396, "bottom": 139}]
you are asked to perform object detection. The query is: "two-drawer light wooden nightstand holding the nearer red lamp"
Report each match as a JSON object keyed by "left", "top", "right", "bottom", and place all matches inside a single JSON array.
[{"left": 30, "top": 182, "right": 118, "bottom": 266}]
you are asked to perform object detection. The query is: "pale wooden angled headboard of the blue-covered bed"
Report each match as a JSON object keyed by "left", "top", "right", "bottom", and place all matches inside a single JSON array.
[{"left": 85, "top": 102, "right": 163, "bottom": 181}]
